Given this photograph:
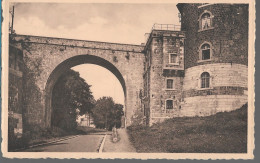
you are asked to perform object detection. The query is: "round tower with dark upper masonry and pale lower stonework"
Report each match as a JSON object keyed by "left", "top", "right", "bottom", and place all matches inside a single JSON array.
[{"left": 177, "top": 3, "right": 248, "bottom": 116}]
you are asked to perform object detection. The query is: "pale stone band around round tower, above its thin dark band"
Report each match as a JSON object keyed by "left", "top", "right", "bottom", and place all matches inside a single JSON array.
[{"left": 183, "top": 63, "right": 248, "bottom": 91}]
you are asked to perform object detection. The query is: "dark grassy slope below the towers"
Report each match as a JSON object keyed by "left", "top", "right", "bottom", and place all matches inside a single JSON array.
[{"left": 128, "top": 104, "right": 247, "bottom": 153}]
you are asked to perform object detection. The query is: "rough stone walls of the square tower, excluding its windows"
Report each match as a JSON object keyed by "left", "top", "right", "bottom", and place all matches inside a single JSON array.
[{"left": 147, "top": 30, "right": 185, "bottom": 124}]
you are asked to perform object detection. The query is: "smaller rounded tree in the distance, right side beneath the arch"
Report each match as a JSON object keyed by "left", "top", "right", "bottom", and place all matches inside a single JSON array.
[{"left": 93, "top": 97, "right": 124, "bottom": 130}]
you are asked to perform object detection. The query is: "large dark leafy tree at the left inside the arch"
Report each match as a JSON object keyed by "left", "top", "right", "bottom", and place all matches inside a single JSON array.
[{"left": 52, "top": 70, "right": 95, "bottom": 130}]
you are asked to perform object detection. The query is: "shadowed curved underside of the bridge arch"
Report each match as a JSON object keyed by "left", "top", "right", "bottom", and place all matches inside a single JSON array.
[{"left": 45, "top": 55, "right": 126, "bottom": 127}]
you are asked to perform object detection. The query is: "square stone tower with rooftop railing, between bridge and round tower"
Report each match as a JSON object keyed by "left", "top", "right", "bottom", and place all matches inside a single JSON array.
[{"left": 142, "top": 24, "right": 185, "bottom": 124}]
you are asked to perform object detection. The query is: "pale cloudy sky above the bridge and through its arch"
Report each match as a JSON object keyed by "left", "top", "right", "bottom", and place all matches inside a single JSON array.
[{"left": 10, "top": 3, "right": 180, "bottom": 104}]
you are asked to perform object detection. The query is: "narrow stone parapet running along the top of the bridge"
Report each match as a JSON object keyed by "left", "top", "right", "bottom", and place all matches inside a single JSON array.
[{"left": 13, "top": 35, "right": 144, "bottom": 53}]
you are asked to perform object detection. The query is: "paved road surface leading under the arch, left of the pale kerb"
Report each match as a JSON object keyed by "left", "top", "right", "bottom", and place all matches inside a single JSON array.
[{"left": 23, "top": 132, "right": 105, "bottom": 152}]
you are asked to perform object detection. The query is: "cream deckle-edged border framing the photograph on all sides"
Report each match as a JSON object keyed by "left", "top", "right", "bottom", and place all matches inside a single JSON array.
[{"left": 1, "top": 0, "right": 255, "bottom": 160}]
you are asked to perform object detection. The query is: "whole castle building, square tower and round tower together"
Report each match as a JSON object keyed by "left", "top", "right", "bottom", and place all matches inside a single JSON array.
[{"left": 141, "top": 3, "right": 248, "bottom": 125}]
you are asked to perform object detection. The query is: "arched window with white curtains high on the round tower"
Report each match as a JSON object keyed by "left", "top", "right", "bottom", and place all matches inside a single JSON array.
[{"left": 199, "top": 11, "right": 213, "bottom": 30}]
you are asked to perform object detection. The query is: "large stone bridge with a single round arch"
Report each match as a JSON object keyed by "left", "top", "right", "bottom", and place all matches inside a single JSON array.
[{"left": 10, "top": 35, "right": 144, "bottom": 127}]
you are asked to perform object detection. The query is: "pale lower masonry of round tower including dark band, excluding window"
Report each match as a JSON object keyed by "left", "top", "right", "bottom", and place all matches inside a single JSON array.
[{"left": 180, "top": 63, "right": 248, "bottom": 116}]
